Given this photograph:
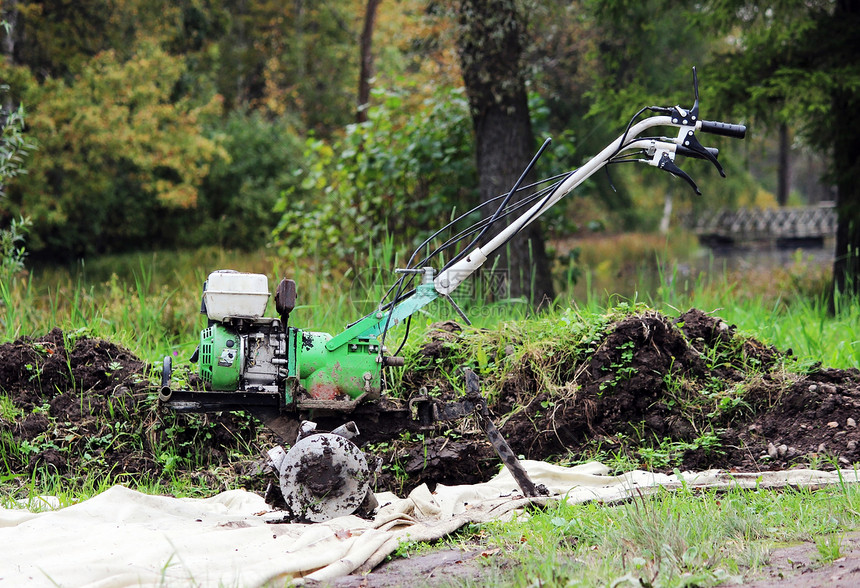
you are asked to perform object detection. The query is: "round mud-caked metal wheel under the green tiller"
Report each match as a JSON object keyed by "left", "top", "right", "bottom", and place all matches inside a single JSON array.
[{"left": 278, "top": 433, "right": 372, "bottom": 523}]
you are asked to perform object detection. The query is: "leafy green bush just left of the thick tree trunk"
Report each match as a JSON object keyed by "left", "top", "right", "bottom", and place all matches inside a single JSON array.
[{"left": 274, "top": 89, "right": 475, "bottom": 266}]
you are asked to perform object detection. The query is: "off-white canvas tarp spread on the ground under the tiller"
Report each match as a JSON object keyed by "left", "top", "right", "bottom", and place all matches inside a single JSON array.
[{"left": 0, "top": 461, "right": 858, "bottom": 588}]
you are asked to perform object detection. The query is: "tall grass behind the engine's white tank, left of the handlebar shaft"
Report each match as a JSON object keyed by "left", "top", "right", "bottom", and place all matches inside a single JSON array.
[{"left": 0, "top": 249, "right": 394, "bottom": 361}]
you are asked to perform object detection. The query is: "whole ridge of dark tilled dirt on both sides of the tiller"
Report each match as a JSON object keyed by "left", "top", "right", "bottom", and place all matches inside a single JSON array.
[{"left": 0, "top": 309, "right": 860, "bottom": 492}]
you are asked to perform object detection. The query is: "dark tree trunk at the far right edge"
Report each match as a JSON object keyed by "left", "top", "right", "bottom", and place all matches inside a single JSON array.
[{"left": 831, "top": 0, "right": 860, "bottom": 296}]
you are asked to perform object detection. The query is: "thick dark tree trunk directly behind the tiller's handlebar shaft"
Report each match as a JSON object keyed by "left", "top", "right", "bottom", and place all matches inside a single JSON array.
[{"left": 457, "top": 0, "right": 555, "bottom": 305}]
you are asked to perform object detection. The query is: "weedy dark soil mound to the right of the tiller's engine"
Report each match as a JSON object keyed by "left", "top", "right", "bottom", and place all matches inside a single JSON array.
[{"left": 387, "top": 309, "right": 860, "bottom": 489}]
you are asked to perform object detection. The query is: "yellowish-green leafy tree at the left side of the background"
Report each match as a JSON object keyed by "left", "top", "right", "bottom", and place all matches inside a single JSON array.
[{"left": 5, "top": 41, "right": 226, "bottom": 255}]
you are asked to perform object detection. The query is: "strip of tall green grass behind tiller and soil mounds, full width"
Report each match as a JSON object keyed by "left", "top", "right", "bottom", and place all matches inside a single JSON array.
[{"left": 0, "top": 237, "right": 860, "bottom": 368}]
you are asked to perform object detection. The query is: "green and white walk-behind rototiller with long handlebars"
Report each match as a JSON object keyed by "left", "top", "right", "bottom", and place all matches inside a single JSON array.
[{"left": 159, "top": 68, "right": 746, "bottom": 522}]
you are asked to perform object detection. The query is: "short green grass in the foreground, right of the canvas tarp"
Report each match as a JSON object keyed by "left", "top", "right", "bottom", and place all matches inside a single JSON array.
[{"left": 444, "top": 474, "right": 860, "bottom": 586}]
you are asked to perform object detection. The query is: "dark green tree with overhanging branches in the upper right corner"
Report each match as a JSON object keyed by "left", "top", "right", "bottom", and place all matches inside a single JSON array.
[{"left": 699, "top": 0, "right": 860, "bottom": 295}]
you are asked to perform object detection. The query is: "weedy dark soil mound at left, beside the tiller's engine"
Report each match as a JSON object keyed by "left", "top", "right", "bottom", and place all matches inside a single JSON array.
[{"left": 0, "top": 329, "right": 268, "bottom": 483}]
